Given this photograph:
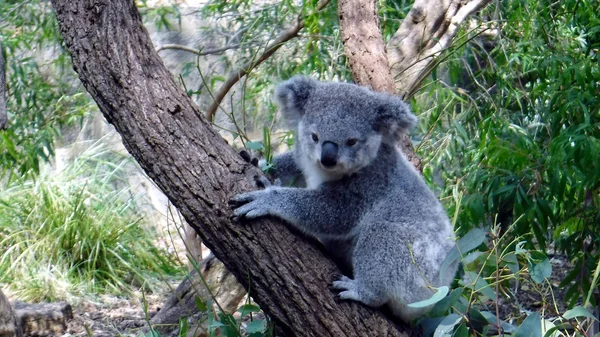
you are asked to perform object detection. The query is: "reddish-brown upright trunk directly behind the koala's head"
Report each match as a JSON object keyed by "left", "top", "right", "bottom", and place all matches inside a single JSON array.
[{"left": 338, "top": 0, "right": 423, "bottom": 171}]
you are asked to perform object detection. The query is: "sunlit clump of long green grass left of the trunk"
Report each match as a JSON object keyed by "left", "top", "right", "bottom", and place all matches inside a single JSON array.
[{"left": 0, "top": 140, "right": 180, "bottom": 301}]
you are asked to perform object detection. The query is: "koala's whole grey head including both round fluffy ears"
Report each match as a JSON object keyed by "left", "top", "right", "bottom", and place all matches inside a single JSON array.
[{"left": 275, "top": 76, "right": 417, "bottom": 174}]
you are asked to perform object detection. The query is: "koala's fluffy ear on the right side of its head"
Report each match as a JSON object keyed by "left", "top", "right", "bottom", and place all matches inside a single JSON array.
[{"left": 374, "top": 93, "right": 418, "bottom": 142}]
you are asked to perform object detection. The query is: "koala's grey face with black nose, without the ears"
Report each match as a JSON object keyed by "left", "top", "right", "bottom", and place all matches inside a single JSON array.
[{"left": 296, "top": 100, "right": 382, "bottom": 175}]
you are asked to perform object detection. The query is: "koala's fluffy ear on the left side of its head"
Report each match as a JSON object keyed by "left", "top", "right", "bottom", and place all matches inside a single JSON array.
[{"left": 275, "top": 76, "right": 318, "bottom": 125}]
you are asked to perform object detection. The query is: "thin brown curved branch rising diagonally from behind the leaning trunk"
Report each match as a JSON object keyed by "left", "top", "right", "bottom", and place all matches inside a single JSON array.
[{"left": 206, "top": 0, "right": 331, "bottom": 121}]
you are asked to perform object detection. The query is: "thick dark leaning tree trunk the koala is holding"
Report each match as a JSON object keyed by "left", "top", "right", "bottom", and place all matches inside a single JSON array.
[{"left": 52, "top": 0, "right": 418, "bottom": 336}]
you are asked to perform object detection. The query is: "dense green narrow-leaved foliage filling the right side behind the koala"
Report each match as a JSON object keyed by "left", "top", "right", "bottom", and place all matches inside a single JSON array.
[{"left": 417, "top": 0, "right": 600, "bottom": 306}]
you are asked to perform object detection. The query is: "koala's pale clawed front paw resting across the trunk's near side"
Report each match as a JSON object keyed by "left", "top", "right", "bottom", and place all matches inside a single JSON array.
[{"left": 230, "top": 188, "right": 277, "bottom": 219}]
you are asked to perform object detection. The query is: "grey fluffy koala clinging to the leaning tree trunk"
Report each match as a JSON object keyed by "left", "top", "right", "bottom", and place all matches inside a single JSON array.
[{"left": 232, "top": 77, "right": 457, "bottom": 322}]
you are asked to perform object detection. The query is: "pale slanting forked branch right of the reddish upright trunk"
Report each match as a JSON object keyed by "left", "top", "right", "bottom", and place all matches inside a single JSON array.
[{"left": 388, "top": 0, "right": 491, "bottom": 99}]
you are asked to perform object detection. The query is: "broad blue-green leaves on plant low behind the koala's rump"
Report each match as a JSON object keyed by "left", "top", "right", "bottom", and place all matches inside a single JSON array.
[{"left": 420, "top": 226, "right": 596, "bottom": 337}]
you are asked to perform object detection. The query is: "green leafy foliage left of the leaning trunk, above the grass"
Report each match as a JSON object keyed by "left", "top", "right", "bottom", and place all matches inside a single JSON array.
[{"left": 0, "top": 0, "right": 95, "bottom": 179}]
